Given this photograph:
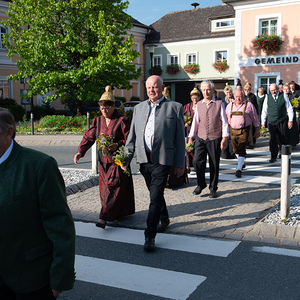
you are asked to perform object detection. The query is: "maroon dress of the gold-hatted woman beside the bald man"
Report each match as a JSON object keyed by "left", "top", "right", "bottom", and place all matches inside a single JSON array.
[{"left": 78, "top": 110, "right": 135, "bottom": 221}]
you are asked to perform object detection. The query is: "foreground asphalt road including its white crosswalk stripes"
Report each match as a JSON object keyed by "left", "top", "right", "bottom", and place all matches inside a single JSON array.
[{"left": 60, "top": 224, "right": 300, "bottom": 300}]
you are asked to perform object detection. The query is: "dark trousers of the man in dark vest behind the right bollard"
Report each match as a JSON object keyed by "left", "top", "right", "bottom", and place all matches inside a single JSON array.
[{"left": 268, "top": 121, "right": 288, "bottom": 159}]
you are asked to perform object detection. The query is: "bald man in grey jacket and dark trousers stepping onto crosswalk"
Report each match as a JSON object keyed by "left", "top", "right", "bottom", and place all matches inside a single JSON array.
[{"left": 123, "top": 75, "right": 185, "bottom": 251}]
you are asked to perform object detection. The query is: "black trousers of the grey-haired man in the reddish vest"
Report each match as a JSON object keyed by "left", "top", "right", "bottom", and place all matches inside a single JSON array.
[{"left": 193, "top": 136, "right": 221, "bottom": 192}]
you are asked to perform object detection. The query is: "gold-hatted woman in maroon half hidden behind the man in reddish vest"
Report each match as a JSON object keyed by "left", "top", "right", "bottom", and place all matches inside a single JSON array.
[{"left": 183, "top": 87, "right": 202, "bottom": 172}]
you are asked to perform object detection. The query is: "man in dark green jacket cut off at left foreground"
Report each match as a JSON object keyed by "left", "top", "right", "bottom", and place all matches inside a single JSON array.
[{"left": 0, "top": 108, "right": 75, "bottom": 300}]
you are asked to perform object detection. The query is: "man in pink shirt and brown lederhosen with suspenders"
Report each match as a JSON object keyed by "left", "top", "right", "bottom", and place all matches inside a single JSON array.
[{"left": 226, "top": 90, "right": 260, "bottom": 177}]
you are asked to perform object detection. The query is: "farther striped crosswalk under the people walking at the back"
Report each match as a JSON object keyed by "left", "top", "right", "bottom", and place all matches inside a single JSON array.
[{"left": 189, "top": 149, "right": 300, "bottom": 185}]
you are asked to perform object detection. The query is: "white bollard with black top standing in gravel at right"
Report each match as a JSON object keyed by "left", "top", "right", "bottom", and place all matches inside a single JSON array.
[{"left": 280, "top": 145, "right": 292, "bottom": 222}]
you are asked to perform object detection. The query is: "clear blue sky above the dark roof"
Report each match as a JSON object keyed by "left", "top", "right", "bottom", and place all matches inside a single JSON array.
[{"left": 125, "top": 0, "right": 222, "bottom": 25}]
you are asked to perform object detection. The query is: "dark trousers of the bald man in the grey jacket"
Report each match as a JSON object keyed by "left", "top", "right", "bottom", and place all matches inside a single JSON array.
[{"left": 140, "top": 162, "right": 170, "bottom": 238}]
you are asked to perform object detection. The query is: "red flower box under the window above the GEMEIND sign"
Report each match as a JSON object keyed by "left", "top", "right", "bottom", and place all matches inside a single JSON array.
[{"left": 252, "top": 34, "right": 283, "bottom": 55}]
